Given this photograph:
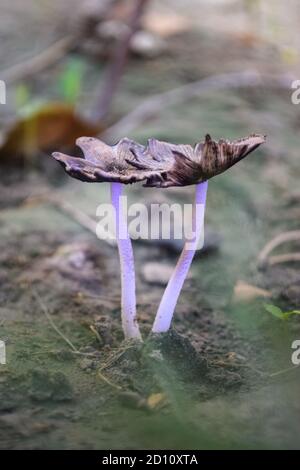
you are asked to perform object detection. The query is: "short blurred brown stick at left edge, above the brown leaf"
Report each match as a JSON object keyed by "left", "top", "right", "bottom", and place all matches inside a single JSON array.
[{"left": 0, "top": 35, "right": 74, "bottom": 84}]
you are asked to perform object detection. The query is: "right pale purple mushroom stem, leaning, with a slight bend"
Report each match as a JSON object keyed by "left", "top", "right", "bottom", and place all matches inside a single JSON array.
[{"left": 152, "top": 181, "right": 208, "bottom": 333}]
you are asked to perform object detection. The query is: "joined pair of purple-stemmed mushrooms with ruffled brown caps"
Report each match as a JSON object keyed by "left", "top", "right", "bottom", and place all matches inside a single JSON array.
[{"left": 53, "top": 134, "right": 265, "bottom": 339}]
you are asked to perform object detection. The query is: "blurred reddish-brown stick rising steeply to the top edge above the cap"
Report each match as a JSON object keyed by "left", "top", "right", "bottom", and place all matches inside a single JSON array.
[{"left": 92, "top": 0, "right": 149, "bottom": 122}]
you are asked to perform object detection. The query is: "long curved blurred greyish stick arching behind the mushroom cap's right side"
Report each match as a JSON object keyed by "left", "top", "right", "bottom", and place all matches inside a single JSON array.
[{"left": 101, "top": 71, "right": 294, "bottom": 142}]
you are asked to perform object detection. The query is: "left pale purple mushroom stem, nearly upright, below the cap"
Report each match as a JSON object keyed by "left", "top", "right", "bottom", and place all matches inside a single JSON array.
[{"left": 111, "top": 183, "right": 141, "bottom": 339}]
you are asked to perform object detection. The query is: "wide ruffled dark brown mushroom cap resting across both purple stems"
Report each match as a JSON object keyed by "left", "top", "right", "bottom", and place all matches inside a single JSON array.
[{"left": 53, "top": 134, "right": 266, "bottom": 188}]
